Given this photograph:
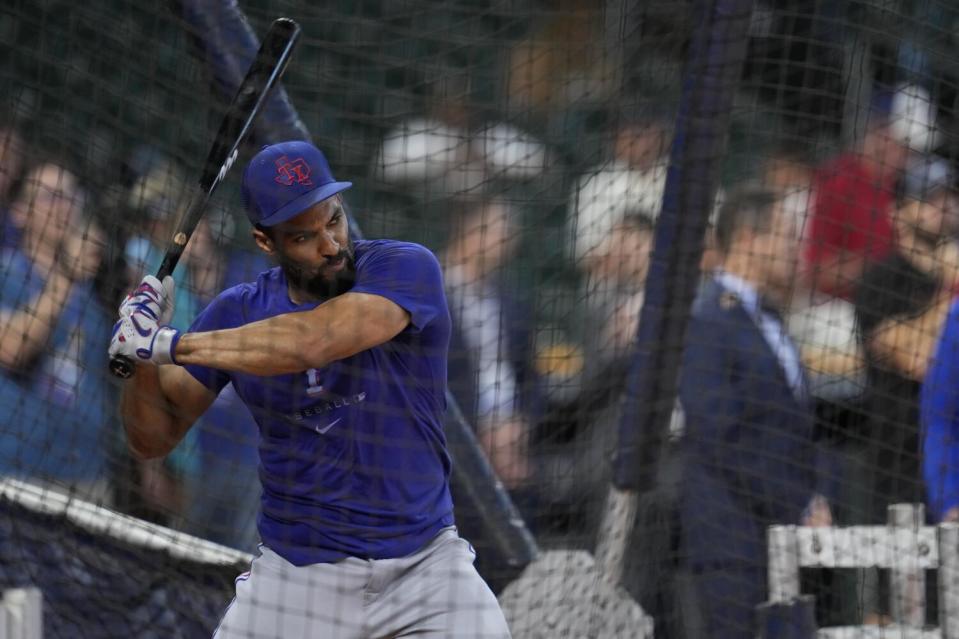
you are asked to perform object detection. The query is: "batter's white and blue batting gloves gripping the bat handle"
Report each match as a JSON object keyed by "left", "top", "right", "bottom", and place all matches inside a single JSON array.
[{"left": 109, "top": 275, "right": 180, "bottom": 364}]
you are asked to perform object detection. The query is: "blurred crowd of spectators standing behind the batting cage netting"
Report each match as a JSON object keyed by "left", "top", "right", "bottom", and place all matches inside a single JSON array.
[{"left": 0, "top": 8, "right": 959, "bottom": 637}]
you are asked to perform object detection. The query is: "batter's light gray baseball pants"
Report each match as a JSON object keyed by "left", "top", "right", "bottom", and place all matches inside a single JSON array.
[{"left": 213, "top": 528, "right": 510, "bottom": 639}]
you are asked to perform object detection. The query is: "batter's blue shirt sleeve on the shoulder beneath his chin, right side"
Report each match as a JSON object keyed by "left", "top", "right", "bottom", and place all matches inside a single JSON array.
[{"left": 351, "top": 243, "right": 448, "bottom": 332}]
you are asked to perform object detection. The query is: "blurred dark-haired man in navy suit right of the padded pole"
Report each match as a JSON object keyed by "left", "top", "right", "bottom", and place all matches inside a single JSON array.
[{"left": 677, "top": 188, "right": 831, "bottom": 639}]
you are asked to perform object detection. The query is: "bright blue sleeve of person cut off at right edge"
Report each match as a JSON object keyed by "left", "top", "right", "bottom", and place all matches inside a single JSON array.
[{"left": 920, "top": 305, "right": 959, "bottom": 520}]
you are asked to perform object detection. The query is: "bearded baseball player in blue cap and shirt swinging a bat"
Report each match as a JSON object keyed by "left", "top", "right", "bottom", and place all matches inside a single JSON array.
[{"left": 109, "top": 141, "right": 509, "bottom": 639}]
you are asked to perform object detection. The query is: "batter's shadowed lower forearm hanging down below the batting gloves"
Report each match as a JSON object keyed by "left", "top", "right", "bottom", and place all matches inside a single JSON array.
[{"left": 120, "top": 364, "right": 179, "bottom": 459}]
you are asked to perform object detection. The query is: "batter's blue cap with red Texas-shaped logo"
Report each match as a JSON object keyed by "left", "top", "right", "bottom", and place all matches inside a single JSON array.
[{"left": 241, "top": 140, "right": 353, "bottom": 226}]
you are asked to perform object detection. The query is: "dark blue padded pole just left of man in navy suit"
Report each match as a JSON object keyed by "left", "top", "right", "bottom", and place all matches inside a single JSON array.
[{"left": 613, "top": 0, "right": 753, "bottom": 491}]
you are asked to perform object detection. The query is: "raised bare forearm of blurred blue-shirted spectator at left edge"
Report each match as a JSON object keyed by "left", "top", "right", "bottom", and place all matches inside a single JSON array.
[{"left": 0, "top": 271, "right": 73, "bottom": 370}]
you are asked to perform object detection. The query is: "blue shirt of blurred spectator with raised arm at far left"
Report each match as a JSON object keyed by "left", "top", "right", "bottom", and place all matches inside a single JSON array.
[{"left": 0, "top": 249, "right": 116, "bottom": 481}]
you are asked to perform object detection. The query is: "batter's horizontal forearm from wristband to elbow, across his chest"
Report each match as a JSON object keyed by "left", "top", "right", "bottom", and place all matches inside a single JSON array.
[{"left": 174, "top": 313, "right": 320, "bottom": 377}]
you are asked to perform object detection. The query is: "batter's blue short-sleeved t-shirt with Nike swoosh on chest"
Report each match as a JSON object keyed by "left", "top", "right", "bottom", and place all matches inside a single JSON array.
[{"left": 186, "top": 240, "right": 453, "bottom": 566}]
